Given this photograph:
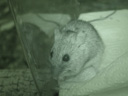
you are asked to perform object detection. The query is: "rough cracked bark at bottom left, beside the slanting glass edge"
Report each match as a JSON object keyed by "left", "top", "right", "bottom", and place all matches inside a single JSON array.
[{"left": 0, "top": 69, "right": 40, "bottom": 96}]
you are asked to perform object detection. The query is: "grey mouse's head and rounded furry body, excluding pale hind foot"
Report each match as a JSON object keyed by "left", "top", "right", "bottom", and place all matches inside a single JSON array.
[{"left": 50, "top": 20, "right": 103, "bottom": 80}]
